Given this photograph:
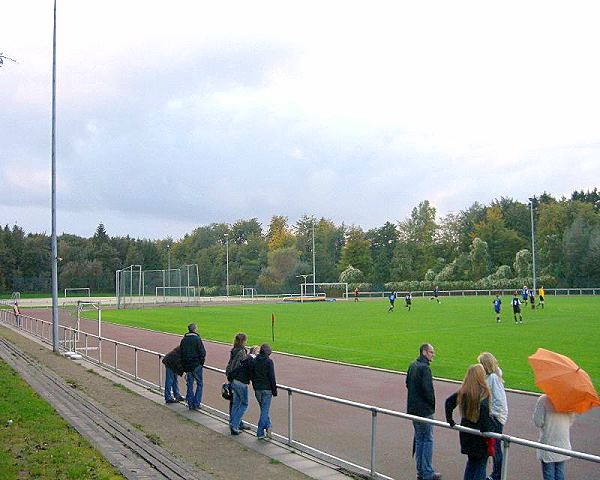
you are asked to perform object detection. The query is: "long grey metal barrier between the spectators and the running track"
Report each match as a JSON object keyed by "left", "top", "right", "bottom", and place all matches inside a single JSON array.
[{"left": 0, "top": 310, "right": 600, "bottom": 480}]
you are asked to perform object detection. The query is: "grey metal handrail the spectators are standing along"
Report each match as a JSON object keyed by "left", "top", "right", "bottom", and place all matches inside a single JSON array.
[{"left": 0, "top": 310, "right": 600, "bottom": 480}]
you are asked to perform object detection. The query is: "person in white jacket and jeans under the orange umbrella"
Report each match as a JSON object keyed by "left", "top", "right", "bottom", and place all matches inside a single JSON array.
[{"left": 533, "top": 395, "right": 575, "bottom": 480}]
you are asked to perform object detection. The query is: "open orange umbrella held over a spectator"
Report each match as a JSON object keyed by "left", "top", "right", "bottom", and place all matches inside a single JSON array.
[{"left": 529, "top": 348, "right": 600, "bottom": 413}]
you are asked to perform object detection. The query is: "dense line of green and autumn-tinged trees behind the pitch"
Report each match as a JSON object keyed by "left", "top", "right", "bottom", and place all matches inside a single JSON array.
[{"left": 0, "top": 189, "right": 600, "bottom": 295}]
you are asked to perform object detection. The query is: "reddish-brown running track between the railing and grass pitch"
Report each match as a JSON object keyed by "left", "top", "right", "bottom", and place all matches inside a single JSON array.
[{"left": 33, "top": 310, "right": 600, "bottom": 480}]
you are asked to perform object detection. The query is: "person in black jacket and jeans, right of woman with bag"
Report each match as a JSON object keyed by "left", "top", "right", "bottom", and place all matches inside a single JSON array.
[{"left": 251, "top": 343, "right": 277, "bottom": 440}]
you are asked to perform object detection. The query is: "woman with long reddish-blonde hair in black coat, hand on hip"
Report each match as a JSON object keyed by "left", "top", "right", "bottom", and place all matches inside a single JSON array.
[{"left": 446, "top": 364, "right": 495, "bottom": 480}]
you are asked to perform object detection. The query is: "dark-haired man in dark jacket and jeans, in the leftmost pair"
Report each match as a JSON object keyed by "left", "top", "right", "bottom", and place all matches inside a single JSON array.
[{"left": 179, "top": 323, "right": 206, "bottom": 410}]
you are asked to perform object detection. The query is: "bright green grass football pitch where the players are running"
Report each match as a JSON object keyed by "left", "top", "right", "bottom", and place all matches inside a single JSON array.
[{"left": 92, "top": 296, "right": 600, "bottom": 391}]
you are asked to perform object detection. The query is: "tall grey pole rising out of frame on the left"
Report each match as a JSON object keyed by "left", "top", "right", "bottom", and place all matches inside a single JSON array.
[{"left": 51, "top": 0, "right": 58, "bottom": 352}]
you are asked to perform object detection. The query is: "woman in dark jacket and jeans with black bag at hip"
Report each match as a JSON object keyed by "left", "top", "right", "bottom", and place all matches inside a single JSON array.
[{"left": 225, "top": 332, "right": 252, "bottom": 435}]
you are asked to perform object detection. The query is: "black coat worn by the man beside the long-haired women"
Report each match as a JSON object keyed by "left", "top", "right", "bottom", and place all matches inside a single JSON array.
[{"left": 406, "top": 355, "right": 435, "bottom": 417}]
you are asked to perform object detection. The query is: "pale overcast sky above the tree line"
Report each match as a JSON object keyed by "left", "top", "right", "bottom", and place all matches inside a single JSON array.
[{"left": 0, "top": 0, "right": 600, "bottom": 239}]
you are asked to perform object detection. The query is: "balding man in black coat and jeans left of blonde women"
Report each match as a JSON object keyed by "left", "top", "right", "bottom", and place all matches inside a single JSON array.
[{"left": 406, "top": 343, "right": 442, "bottom": 480}]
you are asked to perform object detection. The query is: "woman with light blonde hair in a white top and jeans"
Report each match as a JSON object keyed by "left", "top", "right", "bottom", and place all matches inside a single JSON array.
[{"left": 477, "top": 352, "right": 508, "bottom": 480}]
